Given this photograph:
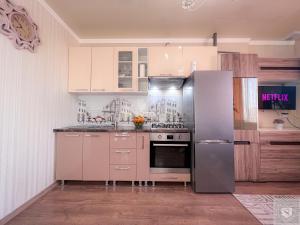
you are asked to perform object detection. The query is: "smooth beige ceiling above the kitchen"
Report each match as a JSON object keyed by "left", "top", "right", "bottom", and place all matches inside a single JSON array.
[{"left": 45, "top": 0, "right": 300, "bottom": 40}]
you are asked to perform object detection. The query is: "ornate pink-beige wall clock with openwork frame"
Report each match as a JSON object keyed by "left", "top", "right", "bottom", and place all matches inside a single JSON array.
[{"left": 0, "top": 0, "right": 40, "bottom": 52}]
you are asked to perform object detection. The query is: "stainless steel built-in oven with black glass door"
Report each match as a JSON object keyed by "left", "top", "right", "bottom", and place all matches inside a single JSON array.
[{"left": 150, "top": 133, "right": 191, "bottom": 173}]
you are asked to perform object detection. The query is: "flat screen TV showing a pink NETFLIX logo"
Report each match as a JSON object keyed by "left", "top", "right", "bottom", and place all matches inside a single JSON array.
[{"left": 258, "top": 86, "right": 296, "bottom": 110}]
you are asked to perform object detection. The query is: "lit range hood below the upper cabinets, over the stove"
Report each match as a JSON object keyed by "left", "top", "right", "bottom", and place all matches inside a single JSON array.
[{"left": 148, "top": 75, "right": 186, "bottom": 90}]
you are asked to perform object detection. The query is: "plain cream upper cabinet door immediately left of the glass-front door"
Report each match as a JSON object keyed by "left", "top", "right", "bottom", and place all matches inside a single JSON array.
[{"left": 91, "top": 47, "right": 114, "bottom": 92}]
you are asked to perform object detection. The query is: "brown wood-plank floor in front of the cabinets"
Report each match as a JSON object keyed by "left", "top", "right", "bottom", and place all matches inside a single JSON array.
[{"left": 8, "top": 183, "right": 300, "bottom": 225}]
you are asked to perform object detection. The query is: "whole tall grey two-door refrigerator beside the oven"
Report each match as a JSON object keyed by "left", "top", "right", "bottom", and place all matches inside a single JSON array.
[{"left": 183, "top": 71, "right": 234, "bottom": 193}]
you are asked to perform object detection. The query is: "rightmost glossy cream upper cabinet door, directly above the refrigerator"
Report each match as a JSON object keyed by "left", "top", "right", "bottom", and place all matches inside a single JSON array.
[{"left": 183, "top": 46, "right": 218, "bottom": 76}]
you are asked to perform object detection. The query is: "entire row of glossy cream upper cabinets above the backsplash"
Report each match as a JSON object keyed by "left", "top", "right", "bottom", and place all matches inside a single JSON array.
[{"left": 69, "top": 46, "right": 218, "bottom": 92}]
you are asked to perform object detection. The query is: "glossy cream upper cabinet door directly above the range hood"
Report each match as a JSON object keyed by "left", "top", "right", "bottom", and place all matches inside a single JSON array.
[{"left": 149, "top": 46, "right": 184, "bottom": 76}]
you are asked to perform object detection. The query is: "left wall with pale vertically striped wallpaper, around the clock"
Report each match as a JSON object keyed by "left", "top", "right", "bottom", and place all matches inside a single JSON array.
[{"left": 0, "top": 0, "right": 76, "bottom": 219}]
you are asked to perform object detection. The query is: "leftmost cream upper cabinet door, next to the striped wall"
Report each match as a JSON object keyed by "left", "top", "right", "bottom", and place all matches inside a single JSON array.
[{"left": 69, "top": 47, "right": 92, "bottom": 92}]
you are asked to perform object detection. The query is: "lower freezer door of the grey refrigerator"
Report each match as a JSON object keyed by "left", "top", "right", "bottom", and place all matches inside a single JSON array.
[{"left": 193, "top": 143, "right": 235, "bottom": 193}]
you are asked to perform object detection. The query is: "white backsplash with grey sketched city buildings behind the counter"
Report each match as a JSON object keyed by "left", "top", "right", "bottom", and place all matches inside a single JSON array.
[{"left": 77, "top": 90, "right": 182, "bottom": 125}]
